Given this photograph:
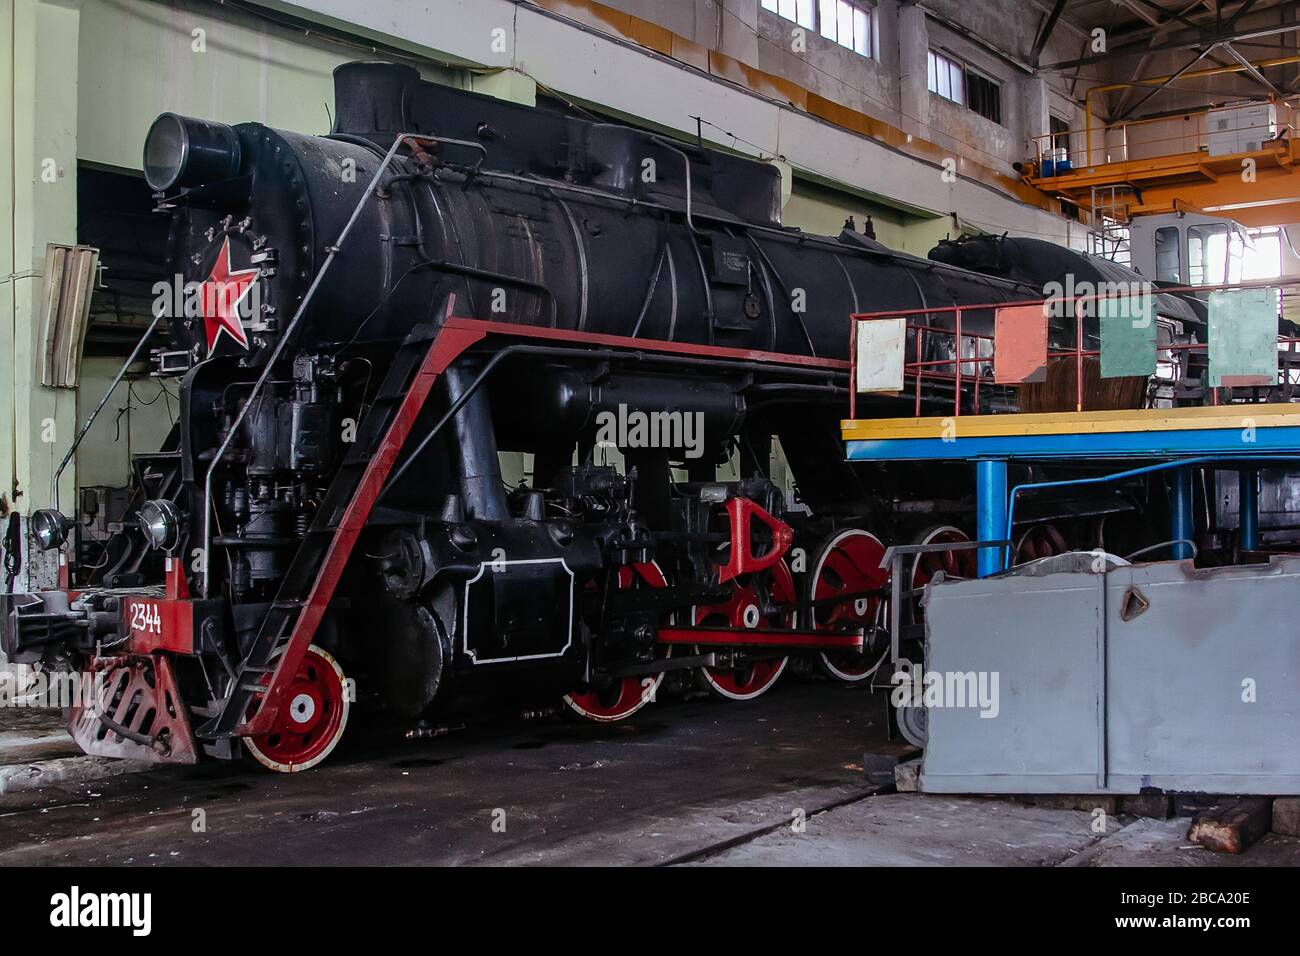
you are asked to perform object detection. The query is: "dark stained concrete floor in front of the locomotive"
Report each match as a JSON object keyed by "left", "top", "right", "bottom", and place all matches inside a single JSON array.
[{"left": 0, "top": 680, "right": 1300, "bottom": 866}]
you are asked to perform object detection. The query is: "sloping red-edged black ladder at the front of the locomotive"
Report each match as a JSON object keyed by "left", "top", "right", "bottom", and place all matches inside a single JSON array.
[{"left": 196, "top": 303, "right": 486, "bottom": 739}]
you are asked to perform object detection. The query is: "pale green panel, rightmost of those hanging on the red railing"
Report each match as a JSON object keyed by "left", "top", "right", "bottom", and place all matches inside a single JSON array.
[{"left": 1209, "top": 289, "right": 1278, "bottom": 388}]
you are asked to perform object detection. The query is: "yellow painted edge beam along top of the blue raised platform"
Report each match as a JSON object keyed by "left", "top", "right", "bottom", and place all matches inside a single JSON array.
[{"left": 840, "top": 405, "right": 1300, "bottom": 441}]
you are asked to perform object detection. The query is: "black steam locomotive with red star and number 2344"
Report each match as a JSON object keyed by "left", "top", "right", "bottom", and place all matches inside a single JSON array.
[{"left": 3, "top": 62, "right": 1197, "bottom": 771}]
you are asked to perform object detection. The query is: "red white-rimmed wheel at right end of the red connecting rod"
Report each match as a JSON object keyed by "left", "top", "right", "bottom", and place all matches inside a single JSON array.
[{"left": 810, "top": 528, "right": 889, "bottom": 684}]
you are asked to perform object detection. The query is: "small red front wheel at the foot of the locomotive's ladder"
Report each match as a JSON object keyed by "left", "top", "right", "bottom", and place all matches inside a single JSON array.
[{"left": 243, "top": 644, "right": 351, "bottom": 774}]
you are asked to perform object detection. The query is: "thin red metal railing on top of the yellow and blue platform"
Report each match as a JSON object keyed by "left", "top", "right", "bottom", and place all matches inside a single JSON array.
[{"left": 849, "top": 278, "right": 1300, "bottom": 418}]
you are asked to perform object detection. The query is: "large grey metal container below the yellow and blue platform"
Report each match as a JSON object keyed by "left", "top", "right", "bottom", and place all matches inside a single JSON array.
[{"left": 920, "top": 555, "right": 1300, "bottom": 793}]
